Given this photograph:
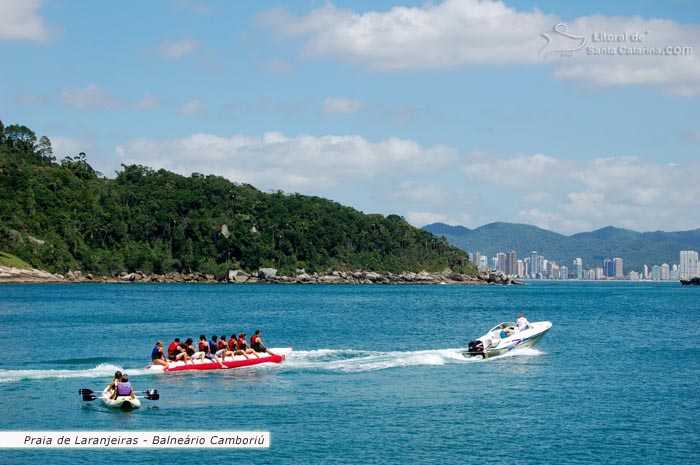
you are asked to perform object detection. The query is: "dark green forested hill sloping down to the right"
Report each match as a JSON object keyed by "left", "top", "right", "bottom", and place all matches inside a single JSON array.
[{"left": 0, "top": 122, "right": 475, "bottom": 276}]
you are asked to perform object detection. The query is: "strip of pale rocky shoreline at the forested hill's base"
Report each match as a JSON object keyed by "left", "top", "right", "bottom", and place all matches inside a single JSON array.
[{"left": 0, "top": 266, "right": 520, "bottom": 284}]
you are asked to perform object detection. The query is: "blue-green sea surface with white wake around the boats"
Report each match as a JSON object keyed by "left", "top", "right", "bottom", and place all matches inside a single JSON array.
[{"left": 0, "top": 282, "right": 700, "bottom": 465}]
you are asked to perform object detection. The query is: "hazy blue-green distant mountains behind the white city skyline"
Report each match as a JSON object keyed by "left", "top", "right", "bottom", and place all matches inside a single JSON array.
[{"left": 423, "top": 222, "right": 700, "bottom": 273}]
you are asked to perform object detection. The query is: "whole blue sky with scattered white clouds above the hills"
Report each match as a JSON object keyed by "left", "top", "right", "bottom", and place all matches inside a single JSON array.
[{"left": 0, "top": 0, "right": 700, "bottom": 235}]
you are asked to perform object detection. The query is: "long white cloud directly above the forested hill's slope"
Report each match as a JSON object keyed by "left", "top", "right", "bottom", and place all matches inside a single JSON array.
[{"left": 116, "top": 132, "right": 456, "bottom": 192}]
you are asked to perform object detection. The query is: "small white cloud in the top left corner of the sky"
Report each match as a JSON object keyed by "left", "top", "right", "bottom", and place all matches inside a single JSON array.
[{"left": 0, "top": 0, "right": 50, "bottom": 42}]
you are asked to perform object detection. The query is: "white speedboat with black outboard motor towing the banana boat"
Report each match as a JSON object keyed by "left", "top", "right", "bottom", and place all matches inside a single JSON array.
[{"left": 462, "top": 321, "right": 552, "bottom": 358}]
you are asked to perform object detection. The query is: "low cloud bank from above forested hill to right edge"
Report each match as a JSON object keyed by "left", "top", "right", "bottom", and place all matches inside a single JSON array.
[{"left": 108, "top": 127, "right": 700, "bottom": 234}]
